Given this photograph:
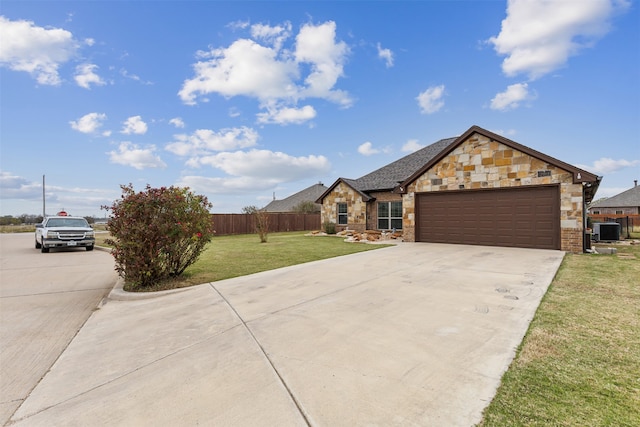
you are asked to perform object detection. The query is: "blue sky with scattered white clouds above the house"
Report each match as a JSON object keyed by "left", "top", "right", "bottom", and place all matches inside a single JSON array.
[{"left": 0, "top": 0, "right": 640, "bottom": 216}]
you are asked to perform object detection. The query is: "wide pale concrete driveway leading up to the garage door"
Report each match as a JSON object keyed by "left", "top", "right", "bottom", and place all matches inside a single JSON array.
[{"left": 7, "top": 243, "right": 564, "bottom": 426}]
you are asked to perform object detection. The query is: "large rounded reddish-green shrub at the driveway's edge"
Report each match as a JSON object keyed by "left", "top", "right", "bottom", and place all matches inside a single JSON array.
[{"left": 103, "top": 184, "right": 214, "bottom": 287}]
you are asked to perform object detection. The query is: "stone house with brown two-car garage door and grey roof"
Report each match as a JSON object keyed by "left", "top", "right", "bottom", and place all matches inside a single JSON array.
[{"left": 317, "top": 126, "right": 601, "bottom": 253}]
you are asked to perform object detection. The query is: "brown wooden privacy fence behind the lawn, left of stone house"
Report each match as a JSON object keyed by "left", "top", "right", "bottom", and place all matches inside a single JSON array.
[{"left": 211, "top": 212, "right": 322, "bottom": 236}]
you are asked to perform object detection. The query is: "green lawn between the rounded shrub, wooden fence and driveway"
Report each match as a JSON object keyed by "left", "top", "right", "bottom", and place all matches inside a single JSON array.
[{"left": 120, "top": 232, "right": 388, "bottom": 291}]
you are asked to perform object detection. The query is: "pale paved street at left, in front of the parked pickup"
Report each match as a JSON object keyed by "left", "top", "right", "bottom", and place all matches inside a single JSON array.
[{"left": 0, "top": 233, "right": 117, "bottom": 425}]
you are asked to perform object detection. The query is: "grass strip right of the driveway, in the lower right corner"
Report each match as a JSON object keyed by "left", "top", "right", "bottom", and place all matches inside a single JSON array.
[{"left": 480, "top": 245, "right": 640, "bottom": 427}]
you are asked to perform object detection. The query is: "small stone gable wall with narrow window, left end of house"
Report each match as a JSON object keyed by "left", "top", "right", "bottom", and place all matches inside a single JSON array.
[{"left": 321, "top": 182, "right": 367, "bottom": 232}]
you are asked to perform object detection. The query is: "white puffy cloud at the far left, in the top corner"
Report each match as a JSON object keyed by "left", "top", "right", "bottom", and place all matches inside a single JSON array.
[{"left": 0, "top": 16, "right": 79, "bottom": 86}]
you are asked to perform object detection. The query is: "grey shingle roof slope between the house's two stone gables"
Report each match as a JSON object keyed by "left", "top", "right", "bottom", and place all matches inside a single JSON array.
[{"left": 345, "top": 138, "right": 456, "bottom": 192}]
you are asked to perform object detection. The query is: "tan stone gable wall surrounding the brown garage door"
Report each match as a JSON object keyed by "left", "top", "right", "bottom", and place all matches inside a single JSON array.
[{"left": 403, "top": 133, "right": 584, "bottom": 253}]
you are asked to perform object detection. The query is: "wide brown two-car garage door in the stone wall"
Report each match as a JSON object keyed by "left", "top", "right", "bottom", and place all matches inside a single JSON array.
[{"left": 416, "top": 186, "right": 560, "bottom": 249}]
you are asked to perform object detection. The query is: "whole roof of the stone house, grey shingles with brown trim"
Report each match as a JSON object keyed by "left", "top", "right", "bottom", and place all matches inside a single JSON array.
[{"left": 316, "top": 126, "right": 601, "bottom": 203}]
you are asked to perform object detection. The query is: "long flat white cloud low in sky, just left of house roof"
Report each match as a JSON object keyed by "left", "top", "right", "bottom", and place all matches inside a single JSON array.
[{"left": 189, "top": 149, "right": 330, "bottom": 182}]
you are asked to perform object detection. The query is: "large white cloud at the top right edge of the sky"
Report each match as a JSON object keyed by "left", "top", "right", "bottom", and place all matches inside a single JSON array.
[{"left": 488, "top": 0, "right": 630, "bottom": 79}]
